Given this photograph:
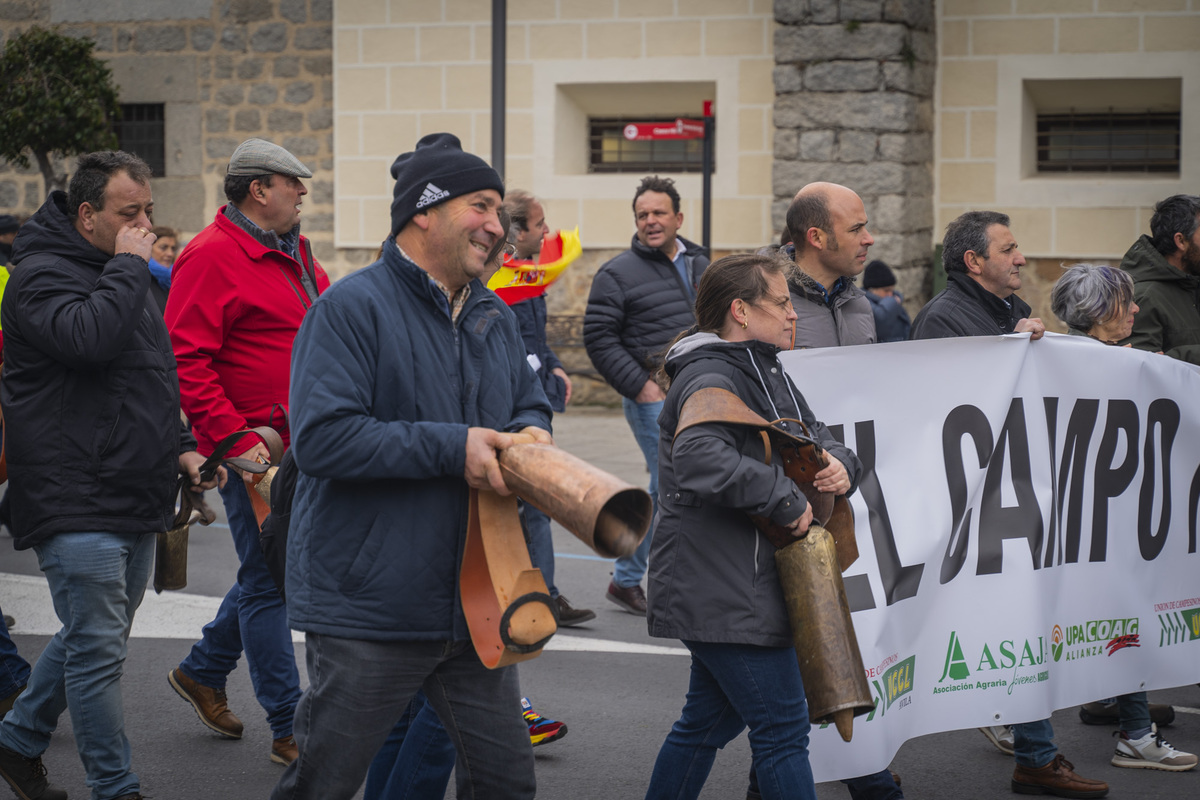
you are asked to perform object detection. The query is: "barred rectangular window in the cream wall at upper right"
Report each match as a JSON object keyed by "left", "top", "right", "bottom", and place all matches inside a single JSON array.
[{"left": 1037, "top": 110, "right": 1180, "bottom": 174}]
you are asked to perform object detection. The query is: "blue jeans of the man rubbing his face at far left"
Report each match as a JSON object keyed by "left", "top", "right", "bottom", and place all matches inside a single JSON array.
[{"left": 0, "top": 533, "right": 155, "bottom": 800}]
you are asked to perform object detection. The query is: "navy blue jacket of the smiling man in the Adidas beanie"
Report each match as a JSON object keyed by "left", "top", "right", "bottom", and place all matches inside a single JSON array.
[{"left": 287, "top": 240, "right": 550, "bottom": 640}]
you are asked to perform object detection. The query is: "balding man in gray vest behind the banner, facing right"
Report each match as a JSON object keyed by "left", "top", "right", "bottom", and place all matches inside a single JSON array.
[{"left": 785, "top": 182, "right": 877, "bottom": 348}]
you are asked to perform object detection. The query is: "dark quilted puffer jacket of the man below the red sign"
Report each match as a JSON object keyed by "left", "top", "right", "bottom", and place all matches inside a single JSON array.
[{"left": 583, "top": 235, "right": 708, "bottom": 399}]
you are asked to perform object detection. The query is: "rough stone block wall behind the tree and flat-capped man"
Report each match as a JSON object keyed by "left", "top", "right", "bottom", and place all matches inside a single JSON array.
[{"left": 0, "top": 0, "right": 371, "bottom": 276}]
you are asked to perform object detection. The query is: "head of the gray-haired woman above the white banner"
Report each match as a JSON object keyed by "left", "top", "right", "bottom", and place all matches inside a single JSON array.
[{"left": 1050, "top": 264, "right": 1138, "bottom": 344}]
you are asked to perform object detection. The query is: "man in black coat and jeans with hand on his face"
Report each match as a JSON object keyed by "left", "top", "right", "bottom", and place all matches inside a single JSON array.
[{"left": 0, "top": 151, "right": 224, "bottom": 800}]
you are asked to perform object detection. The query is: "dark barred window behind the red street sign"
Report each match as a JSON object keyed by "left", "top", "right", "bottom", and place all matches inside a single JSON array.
[{"left": 588, "top": 115, "right": 716, "bottom": 174}]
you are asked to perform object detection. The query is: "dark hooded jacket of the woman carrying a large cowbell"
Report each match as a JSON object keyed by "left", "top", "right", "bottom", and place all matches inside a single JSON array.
[{"left": 647, "top": 333, "right": 863, "bottom": 648}]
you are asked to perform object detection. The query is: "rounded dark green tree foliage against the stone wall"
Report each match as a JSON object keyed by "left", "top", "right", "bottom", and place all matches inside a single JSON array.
[{"left": 0, "top": 26, "right": 121, "bottom": 193}]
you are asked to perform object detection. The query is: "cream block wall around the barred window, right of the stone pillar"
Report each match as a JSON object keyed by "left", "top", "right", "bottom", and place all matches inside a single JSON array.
[{"left": 934, "top": 0, "right": 1200, "bottom": 325}]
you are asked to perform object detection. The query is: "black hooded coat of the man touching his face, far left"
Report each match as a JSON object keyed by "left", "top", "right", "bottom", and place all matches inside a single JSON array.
[{"left": 0, "top": 192, "right": 196, "bottom": 549}]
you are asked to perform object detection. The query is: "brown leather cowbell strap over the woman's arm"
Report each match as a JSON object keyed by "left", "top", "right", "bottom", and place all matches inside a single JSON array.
[{"left": 674, "top": 386, "right": 858, "bottom": 572}]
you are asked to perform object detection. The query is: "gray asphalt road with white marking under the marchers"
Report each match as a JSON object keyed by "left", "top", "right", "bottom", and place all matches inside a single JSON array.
[{"left": 0, "top": 410, "right": 1200, "bottom": 800}]
